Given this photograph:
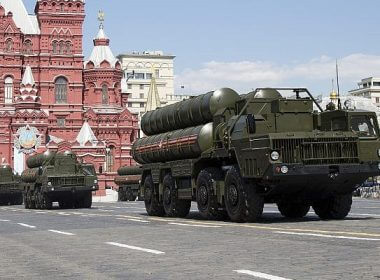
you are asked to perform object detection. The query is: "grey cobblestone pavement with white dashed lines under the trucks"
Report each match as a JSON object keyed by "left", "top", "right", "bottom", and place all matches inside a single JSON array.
[{"left": 0, "top": 199, "right": 380, "bottom": 280}]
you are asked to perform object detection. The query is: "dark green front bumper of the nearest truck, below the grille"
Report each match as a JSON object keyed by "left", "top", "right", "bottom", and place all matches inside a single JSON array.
[{"left": 263, "top": 162, "right": 380, "bottom": 196}]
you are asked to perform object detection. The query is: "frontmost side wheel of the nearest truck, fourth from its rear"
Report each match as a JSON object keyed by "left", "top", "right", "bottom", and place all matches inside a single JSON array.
[{"left": 224, "top": 166, "right": 264, "bottom": 222}]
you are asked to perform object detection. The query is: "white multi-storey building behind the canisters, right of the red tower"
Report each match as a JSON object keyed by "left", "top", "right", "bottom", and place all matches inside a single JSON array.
[{"left": 118, "top": 51, "right": 188, "bottom": 115}]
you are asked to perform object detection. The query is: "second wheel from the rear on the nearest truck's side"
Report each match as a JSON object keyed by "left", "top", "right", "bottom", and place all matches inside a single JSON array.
[{"left": 163, "top": 174, "right": 191, "bottom": 218}]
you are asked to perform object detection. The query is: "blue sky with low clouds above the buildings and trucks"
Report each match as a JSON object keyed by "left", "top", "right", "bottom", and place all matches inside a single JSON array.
[{"left": 24, "top": 0, "right": 380, "bottom": 94}]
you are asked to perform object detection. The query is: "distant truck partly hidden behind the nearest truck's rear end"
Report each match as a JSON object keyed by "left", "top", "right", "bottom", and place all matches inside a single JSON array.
[{"left": 114, "top": 166, "right": 142, "bottom": 201}]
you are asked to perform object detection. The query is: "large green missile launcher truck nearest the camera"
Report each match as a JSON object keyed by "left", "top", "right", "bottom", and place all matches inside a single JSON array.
[{"left": 132, "top": 88, "right": 380, "bottom": 222}]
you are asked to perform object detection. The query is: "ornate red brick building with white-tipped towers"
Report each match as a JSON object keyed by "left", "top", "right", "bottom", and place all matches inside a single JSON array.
[{"left": 0, "top": 0, "right": 138, "bottom": 195}]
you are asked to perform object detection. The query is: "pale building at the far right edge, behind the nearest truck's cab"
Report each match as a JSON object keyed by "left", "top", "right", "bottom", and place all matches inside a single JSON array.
[{"left": 348, "top": 77, "right": 380, "bottom": 107}]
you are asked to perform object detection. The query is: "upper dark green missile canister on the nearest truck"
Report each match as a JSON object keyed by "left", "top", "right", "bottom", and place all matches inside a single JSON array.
[{"left": 141, "top": 88, "right": 240, "bottom": 136}]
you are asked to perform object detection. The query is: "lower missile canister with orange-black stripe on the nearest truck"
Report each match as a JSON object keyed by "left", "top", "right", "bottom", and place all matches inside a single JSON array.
[{"left": 132, "top": 123, "right": 213, "bottom": 164}]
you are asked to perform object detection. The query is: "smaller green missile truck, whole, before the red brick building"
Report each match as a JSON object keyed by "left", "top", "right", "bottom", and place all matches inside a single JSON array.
[{"left": 21, "top": 151, "right": 99, "bottom": 209}]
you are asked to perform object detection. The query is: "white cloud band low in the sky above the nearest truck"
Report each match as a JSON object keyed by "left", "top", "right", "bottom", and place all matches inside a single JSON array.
[{"left": 175, "top": 53, "right": 380, "bottom": 94}]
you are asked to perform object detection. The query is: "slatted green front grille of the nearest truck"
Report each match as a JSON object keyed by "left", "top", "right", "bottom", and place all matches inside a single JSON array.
[{"left": 272, "top": 137, "right": 359, "bottom": 165}]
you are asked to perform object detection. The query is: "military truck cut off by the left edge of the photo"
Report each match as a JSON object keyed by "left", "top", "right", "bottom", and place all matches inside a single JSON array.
[{"left": 0, "top": 165, "right": 22, "bottom": 206}]
